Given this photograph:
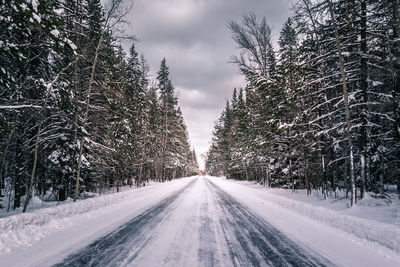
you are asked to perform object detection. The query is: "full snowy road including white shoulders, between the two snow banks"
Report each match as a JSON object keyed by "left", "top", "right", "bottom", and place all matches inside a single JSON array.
[{"left": 0, "top": 177, "right": 399, "bottom": 267}]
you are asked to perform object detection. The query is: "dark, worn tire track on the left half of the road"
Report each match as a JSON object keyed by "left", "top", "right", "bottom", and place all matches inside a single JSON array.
[{"left": 54, "top": 180, "right": 197, "bottom": 267}]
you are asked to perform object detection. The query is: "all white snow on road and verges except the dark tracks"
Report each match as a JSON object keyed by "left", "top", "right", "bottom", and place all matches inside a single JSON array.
[{"left": 0, "top": 177, "right": 400, "bottom": 266}]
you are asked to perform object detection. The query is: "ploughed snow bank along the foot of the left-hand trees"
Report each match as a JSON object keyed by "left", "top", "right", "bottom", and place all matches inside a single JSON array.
[{"left": 0, "top": 179, "right": 194, "bottom": 254}]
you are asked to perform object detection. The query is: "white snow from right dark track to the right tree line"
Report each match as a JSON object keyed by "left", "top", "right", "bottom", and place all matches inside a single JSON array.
[{"left": 210, "top": 178, "right": 400, "bottom": 266}]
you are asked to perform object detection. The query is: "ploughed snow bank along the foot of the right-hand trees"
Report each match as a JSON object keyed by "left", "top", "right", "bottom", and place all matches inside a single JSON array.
[{"left": 212, "top": 179, "right": 400, "bottom": 253}]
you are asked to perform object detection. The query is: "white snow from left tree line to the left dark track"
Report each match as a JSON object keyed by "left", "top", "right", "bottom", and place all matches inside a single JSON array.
[{"left": 0, "top": 178, "right": 193, "bottom": 266}]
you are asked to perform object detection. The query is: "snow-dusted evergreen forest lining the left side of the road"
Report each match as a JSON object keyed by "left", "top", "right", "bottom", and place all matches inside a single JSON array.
[{"left": 0, "top": 0, "right": 198, "bottom": 212}]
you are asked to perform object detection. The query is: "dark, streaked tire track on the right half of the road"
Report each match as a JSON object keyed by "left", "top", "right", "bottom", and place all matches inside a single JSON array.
[{"left": 206, "top": 179, "right": 333, "bottom": 266}]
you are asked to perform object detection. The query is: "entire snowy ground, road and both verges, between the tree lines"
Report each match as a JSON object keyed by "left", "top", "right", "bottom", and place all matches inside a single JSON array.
[{"left": 0, "top": 177, "right": 400, "bottom": 266}]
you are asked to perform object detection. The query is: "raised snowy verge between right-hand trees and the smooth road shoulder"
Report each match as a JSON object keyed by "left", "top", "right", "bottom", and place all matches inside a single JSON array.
[{"left": 211, "top": 178, "right": 400, "bottom": 253}]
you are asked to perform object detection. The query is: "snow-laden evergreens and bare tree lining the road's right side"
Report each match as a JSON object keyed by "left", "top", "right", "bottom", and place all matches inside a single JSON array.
[{"left": 206, "top": 0, "right": 400, "bottom": 205}]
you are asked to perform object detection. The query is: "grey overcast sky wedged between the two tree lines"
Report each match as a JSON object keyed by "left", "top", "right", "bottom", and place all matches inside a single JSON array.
[{"left": 126, "top": 0, "right": 290, "bottom": 167}]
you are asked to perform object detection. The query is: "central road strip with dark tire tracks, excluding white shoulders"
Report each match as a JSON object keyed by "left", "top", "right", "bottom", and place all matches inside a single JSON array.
[{"left": 57, "top": 178, "right": 332, "bottom": 266}]
